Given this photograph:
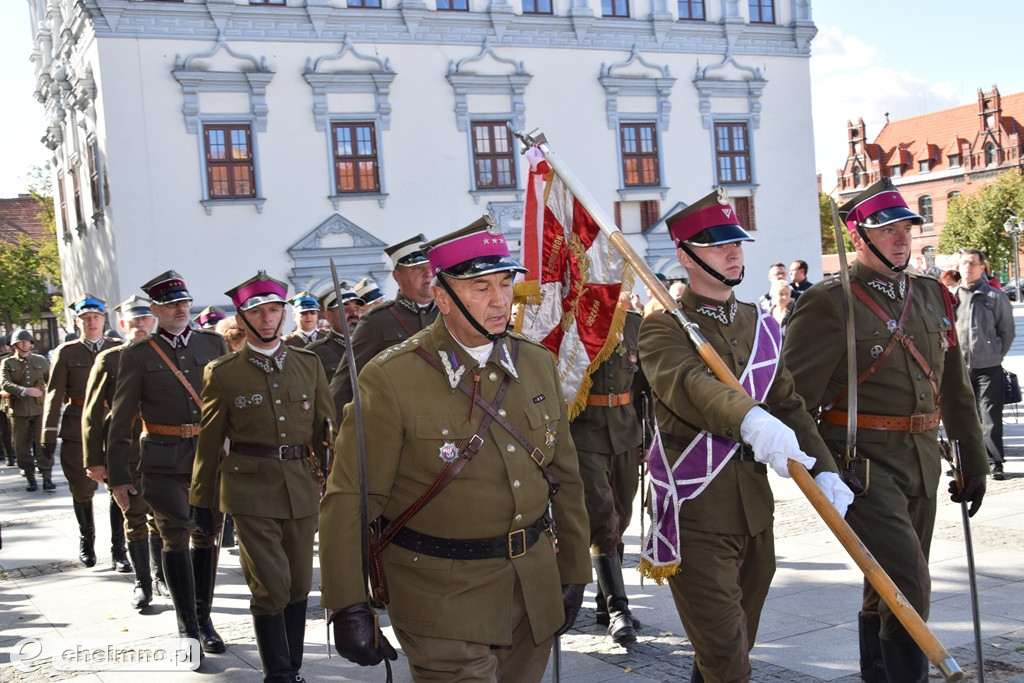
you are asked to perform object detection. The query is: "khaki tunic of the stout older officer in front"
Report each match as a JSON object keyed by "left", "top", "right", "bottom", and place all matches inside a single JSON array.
[{"left": 319, "top": 313, "right": 591, "bottom": 644}]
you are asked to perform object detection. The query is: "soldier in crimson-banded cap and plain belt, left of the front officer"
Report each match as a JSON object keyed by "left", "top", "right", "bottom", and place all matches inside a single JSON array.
[{"left": 189, "top": 270, "right": 335, "bottom": 683}]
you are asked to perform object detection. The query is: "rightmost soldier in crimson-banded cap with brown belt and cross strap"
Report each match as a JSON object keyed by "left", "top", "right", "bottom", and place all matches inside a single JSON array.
[{"left": 784, "top": 178, "right": 988, "bottom": 683}]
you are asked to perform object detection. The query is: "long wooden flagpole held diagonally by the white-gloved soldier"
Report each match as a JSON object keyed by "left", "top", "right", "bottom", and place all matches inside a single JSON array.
[{"left": 508, "top": 123, "right": 964, "bottom": 683}]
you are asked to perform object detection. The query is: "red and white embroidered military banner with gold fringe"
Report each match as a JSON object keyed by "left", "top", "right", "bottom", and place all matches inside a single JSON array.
[{"left": 516, "top": 147, "right": 633, "bottom": 419}]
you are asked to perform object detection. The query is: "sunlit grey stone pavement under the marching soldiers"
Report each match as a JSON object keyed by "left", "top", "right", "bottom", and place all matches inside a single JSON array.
[{"left": 6, "top": 305, "right": 1024, "bottom": 683}]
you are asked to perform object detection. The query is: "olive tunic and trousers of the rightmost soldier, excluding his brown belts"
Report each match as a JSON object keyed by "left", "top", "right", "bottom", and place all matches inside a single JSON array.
[{"left": 783, "top": 262, "right": 988, "bottom": 639}]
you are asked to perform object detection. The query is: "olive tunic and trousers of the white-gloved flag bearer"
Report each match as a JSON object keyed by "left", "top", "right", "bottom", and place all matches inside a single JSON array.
[{"left": 640, "top": 289, "right": 836, "bottom": 681}]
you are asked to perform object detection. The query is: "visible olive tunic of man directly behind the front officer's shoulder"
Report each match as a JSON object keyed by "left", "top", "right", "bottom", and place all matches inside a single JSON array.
[{"left": 328, "top": 292, "right": 437, "bottom": 416}]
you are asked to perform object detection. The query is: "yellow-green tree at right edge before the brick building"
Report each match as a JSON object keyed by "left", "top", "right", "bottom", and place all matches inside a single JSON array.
[{"left": 937, "top": 171, "right": 1024, "bottom": 268}]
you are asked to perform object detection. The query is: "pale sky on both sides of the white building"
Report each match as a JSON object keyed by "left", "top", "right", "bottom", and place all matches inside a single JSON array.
[{"left": 0, "top": 0, "right": 1024, "bottom": 197}]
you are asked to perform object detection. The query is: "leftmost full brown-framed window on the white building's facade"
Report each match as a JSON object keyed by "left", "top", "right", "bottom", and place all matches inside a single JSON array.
[{"left": 203, "top": 124, "right": 256, "bottom": 200}]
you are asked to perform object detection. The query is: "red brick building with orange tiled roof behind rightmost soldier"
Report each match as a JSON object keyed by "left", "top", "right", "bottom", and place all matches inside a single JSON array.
[{"left": 838, "top": 85, "right": 1024, "bottom": 274}]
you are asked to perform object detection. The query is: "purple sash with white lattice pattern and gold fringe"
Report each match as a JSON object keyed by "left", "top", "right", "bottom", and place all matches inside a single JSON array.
[{"left": 638, "top": 308, "right": 782, "bottom": 584}]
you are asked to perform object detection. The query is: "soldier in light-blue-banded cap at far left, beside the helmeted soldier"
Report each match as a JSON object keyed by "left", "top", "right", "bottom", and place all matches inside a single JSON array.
[{"left": 43, "top": 292, "right": 132, "bottom": 573}]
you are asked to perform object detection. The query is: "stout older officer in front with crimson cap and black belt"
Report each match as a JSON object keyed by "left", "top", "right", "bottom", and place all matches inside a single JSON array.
[{"left": 319, "top": 219, "right": 590, "bottom": 681}]
